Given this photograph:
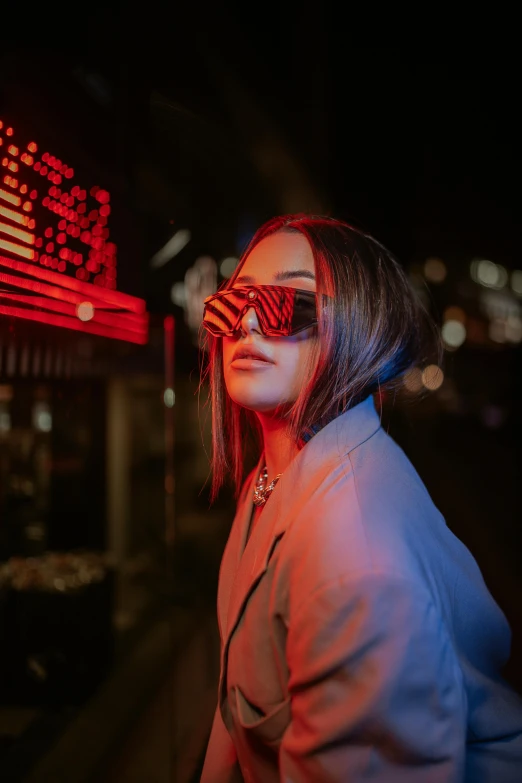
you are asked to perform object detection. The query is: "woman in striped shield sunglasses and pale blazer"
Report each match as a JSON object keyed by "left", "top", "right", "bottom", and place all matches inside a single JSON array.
[{"left": 201, "top": 215, "right": 522, "bottom": 783}]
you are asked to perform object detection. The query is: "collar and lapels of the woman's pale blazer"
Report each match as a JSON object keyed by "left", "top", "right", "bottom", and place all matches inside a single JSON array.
[{"left": 217, "top": 396, "right": 380, "bottom": 688}]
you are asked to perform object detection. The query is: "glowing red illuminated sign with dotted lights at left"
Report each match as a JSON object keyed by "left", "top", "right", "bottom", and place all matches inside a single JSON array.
[{"left": 0, "top": 119, "right": 148, "bottom": 344}]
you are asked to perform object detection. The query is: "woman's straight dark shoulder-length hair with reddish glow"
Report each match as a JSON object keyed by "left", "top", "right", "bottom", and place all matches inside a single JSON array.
[{"left": 202, "top": 214, "right": 441, "bottom": 501}]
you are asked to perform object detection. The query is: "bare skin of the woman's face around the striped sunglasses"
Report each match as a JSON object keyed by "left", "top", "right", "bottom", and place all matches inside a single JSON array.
[{"left": 223, "top": 231, "right": 318, "bottom": 413}]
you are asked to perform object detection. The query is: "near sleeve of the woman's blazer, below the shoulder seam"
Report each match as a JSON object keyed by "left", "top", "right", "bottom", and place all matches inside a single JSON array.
[{"left": 279, "top": 573, "right": 467, "bottom": 783}]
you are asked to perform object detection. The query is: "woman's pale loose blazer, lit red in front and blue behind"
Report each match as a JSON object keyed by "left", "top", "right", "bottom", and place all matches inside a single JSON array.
[{"left": 201, "top": 398, "right": 522, "bottom": 783}]
